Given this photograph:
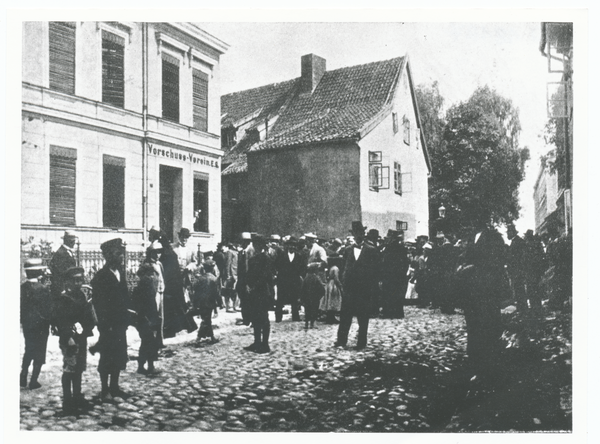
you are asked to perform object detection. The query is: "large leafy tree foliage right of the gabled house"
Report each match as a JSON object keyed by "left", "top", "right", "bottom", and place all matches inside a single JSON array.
[{"left": 417, "top": 83, "right": 529, "bottom": 236}]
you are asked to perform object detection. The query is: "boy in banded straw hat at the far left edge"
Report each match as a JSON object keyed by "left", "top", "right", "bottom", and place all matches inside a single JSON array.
[{"left": 20, "top": 259, "right": 51, "bottom": 389}]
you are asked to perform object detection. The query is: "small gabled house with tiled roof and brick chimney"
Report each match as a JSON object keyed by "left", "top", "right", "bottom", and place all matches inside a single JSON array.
[{"left": 221, "top": 54, "right": 431, "bottom": 243}]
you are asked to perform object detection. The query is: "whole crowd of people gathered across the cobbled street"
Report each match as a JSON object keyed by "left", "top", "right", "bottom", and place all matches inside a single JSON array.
[{"left": 20, "top": 222, "right": 568, "bottom": 414}]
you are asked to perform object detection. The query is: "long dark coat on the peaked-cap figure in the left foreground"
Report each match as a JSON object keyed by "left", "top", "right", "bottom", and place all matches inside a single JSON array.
[{"left": 91, "top": 265, "right": 130, "bottom": 373}]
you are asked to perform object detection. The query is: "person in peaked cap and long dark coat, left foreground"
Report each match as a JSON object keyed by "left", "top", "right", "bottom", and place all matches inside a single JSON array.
[{"left": 91, "top": 238, "right": 130, "bottom": 399}]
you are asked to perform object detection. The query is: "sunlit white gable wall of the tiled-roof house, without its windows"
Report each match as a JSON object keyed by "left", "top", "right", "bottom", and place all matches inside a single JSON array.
[{"left": 359, "top": 62, "right": 429, "bottom": 239}]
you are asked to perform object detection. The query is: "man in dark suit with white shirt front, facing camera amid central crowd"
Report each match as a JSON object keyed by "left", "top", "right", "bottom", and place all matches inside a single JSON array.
[{"left": 275, "top": 237, "right": 306, "bottom": 322}]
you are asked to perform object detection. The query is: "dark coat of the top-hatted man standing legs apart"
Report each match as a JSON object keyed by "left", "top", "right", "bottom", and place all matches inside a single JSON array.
[{"left": 342, "top": 242, "right": 379, "bottom": 313}]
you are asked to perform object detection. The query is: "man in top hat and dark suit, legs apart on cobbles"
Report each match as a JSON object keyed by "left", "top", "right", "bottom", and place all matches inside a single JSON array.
[{"left": 334, "top": 222, "right": 379, "bottom": 350}]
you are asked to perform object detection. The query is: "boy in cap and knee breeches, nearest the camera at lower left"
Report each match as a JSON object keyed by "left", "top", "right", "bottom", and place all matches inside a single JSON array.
[{"left": 52, "top": 267, "right": 96, "bottom": 415}]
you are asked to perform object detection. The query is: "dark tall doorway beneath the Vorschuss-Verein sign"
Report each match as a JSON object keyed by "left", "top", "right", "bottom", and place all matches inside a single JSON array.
[{"left": 159, "top": 165, "right": 183, "bottom": 242}]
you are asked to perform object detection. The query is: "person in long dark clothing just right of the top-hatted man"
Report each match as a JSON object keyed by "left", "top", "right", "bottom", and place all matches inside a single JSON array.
[{"left": 381, "top": 230, "right": 410, "bottom": 319}]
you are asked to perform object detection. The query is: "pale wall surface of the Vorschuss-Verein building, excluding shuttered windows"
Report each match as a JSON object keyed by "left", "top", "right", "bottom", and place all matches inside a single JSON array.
[{"left": 21, "top": 22, "right": 227, "bottom": 250}]
